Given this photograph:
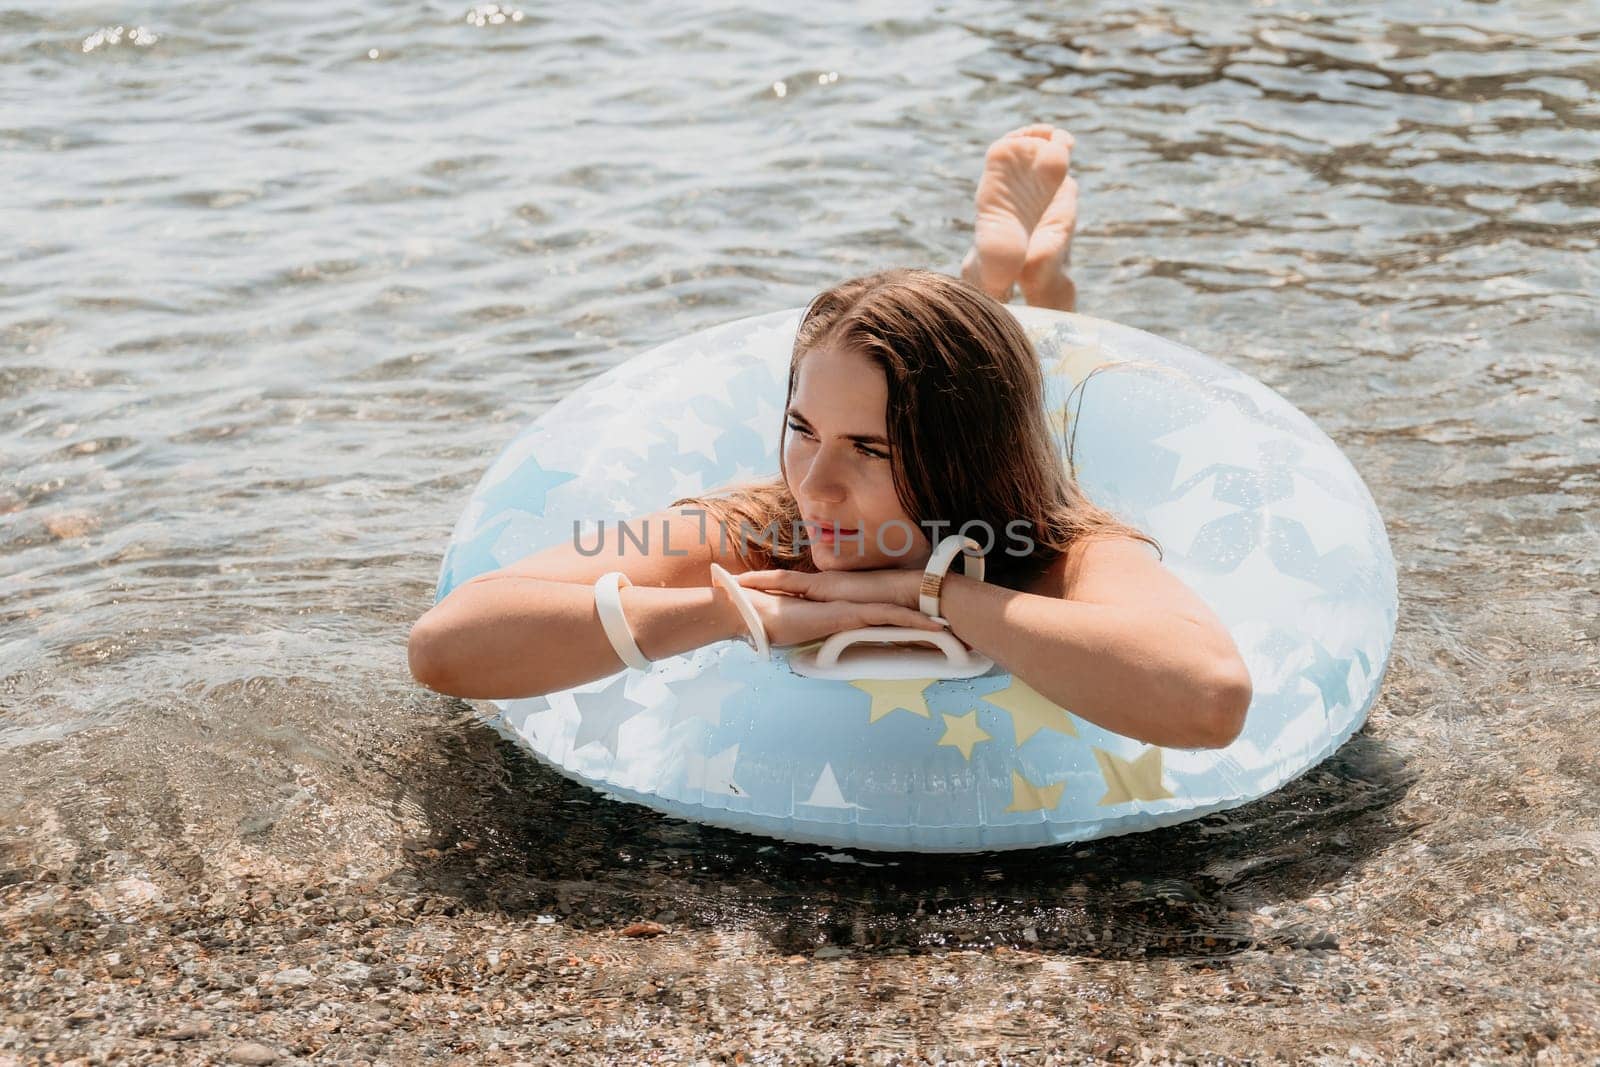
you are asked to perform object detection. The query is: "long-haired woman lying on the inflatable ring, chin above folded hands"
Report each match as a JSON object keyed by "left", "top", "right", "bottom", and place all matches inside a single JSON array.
[{"left": 410, "top": 126, "right": 1251, "bottom": 749}]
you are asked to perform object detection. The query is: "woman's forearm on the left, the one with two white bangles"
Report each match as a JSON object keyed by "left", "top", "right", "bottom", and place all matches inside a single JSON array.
[{"left": 408, "top": 574, "right": 744, "bottom": 699}]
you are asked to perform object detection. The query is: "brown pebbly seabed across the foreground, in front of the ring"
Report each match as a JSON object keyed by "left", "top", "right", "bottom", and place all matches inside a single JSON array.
[{"left": 0, "top": 672, "right": 1600, "bottom": 1064}]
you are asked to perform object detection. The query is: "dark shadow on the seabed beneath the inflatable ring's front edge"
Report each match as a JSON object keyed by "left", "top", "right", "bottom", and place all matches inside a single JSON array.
[{"left": 400, "top": 704, "right": 1414, "bottom": 958}]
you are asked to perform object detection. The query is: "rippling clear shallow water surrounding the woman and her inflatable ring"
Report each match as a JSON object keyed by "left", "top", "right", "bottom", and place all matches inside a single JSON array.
[{"left": 0, "top": 0, "right": 1600, "bottom": 1059}]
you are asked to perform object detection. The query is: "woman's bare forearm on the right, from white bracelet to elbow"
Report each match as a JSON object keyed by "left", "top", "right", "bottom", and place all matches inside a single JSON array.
[{"left": 939, "top": 573, "right": 1251, "bottom": 749}]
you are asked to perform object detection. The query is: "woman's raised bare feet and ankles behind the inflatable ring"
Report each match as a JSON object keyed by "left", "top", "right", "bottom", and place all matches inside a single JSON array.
[{"left": 962, "top": 123, "right": 1078, "bottom": 312}]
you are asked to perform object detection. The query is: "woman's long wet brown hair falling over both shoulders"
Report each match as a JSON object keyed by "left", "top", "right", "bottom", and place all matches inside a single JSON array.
[{"left": 672, "top": 269, "right": 1162, "bottom": 589}]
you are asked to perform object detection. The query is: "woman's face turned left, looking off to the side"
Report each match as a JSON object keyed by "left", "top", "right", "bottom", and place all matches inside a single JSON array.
[{"left": 784, "top": 349, "right": 933, "bottom": 571}]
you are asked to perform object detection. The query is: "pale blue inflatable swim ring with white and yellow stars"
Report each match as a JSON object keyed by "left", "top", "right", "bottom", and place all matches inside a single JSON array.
[{"left": 437, "top": 306, "right": 1397, "bottom": 851}]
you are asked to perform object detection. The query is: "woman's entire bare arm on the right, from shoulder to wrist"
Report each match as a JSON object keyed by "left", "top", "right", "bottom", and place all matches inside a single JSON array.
[{"left": 939, "top": 537, "right": 1251, "bottom": 749}]
